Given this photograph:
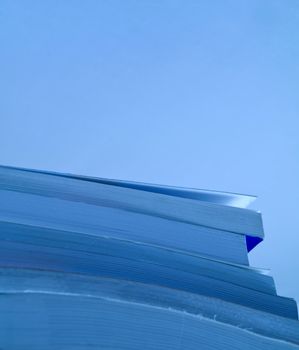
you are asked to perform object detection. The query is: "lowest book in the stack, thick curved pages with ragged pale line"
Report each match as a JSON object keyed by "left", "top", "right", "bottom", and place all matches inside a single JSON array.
[{"left": 0, "top": 268, "right": 299, "bottom": 350}]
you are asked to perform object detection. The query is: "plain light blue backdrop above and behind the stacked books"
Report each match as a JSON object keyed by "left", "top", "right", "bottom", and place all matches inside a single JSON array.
[{"left": 0, "top": 0, "right": 299, "bottom": 300}]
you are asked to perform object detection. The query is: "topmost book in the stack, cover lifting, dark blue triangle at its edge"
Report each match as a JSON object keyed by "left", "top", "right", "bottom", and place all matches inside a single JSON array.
[{"left": 0, "top": 166, "right": 264, "bottom": 265}]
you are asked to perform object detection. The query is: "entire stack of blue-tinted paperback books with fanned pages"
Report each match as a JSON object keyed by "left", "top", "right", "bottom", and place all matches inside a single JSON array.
[{"left": 0, "top": 166, "right": 299, "bottom": 350}]
